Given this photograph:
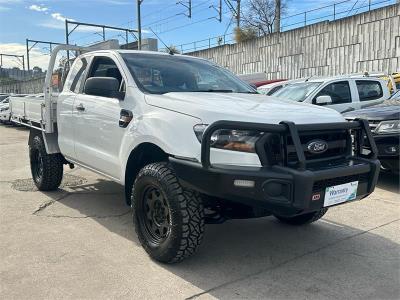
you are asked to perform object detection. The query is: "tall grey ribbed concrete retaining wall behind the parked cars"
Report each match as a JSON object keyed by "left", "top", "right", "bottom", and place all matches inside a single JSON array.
[{"left": 189, "top": 4, "right": 400, "bottom": 79}]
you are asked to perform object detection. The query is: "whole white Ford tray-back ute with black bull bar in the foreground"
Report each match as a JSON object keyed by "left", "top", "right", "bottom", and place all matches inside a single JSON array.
[{"left": 11, "top": 45, "right": 380, "bottom": 263}]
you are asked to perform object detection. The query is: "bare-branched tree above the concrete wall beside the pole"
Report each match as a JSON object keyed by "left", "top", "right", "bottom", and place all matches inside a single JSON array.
[{"left": 242, "top": 0, "right": 286, "bottom": 35}]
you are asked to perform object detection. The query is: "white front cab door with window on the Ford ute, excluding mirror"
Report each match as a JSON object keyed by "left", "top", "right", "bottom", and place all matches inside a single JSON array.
[{"left": 74, "top": 55, "right": 126, "bottom": 180}]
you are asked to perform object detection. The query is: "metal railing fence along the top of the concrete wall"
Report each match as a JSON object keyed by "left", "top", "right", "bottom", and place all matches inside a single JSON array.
[{"left": 160, "top": 0, "right": 396, "bottom": 54}]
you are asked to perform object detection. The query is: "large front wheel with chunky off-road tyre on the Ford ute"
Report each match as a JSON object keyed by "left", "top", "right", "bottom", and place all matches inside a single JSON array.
[{"left": 131, "top": 163, "right": 204, "bottom": 263}]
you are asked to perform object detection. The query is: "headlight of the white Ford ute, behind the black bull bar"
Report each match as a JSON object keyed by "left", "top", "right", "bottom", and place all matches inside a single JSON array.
[{"left": 193, "top": 124, "right": 263, "bottom": 153}]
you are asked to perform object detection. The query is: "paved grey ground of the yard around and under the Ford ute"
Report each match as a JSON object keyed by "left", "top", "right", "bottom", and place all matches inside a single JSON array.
[{"left": 0, "top": 125, "right": 400, "bottom": 299}]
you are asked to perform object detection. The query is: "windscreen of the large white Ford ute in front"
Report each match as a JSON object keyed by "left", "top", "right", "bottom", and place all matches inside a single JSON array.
[{"left": 121, "top": 53, "right": 257, "bottom": 94}]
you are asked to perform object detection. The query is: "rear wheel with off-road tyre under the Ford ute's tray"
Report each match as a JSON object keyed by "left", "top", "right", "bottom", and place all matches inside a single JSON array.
[{"left": 29, "top": 135, "right": 63, "bottom": 191}]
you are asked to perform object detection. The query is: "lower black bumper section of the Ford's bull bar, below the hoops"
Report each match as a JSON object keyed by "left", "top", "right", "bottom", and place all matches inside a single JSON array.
[{"left": 170, "top": 158, "right": 380, "bottom": 215}]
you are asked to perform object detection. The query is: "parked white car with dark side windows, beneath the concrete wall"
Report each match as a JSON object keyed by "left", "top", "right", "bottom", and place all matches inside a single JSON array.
[{"left": 273, "top": 76, "right": 390, "bottom": 112}]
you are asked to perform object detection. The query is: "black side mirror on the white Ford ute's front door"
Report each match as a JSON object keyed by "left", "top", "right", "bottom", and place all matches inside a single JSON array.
[{"left": 83, "top": 77, "right": 124, "bottom": 100}]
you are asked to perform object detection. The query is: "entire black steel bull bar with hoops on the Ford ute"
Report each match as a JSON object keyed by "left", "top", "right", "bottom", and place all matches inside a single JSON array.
[{"left": 170, "top": 121, "right": 380, "bottom": 216}]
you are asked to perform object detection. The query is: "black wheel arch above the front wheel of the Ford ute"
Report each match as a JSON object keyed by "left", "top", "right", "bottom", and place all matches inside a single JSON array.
[{"left": 124, "top": 142, "right": 169, "bottom": 205}]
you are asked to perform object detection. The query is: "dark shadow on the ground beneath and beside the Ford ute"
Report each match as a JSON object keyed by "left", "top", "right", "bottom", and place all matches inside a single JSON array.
[{"left": 39, "top": 179, "right": 400, "bottom": 299}]
